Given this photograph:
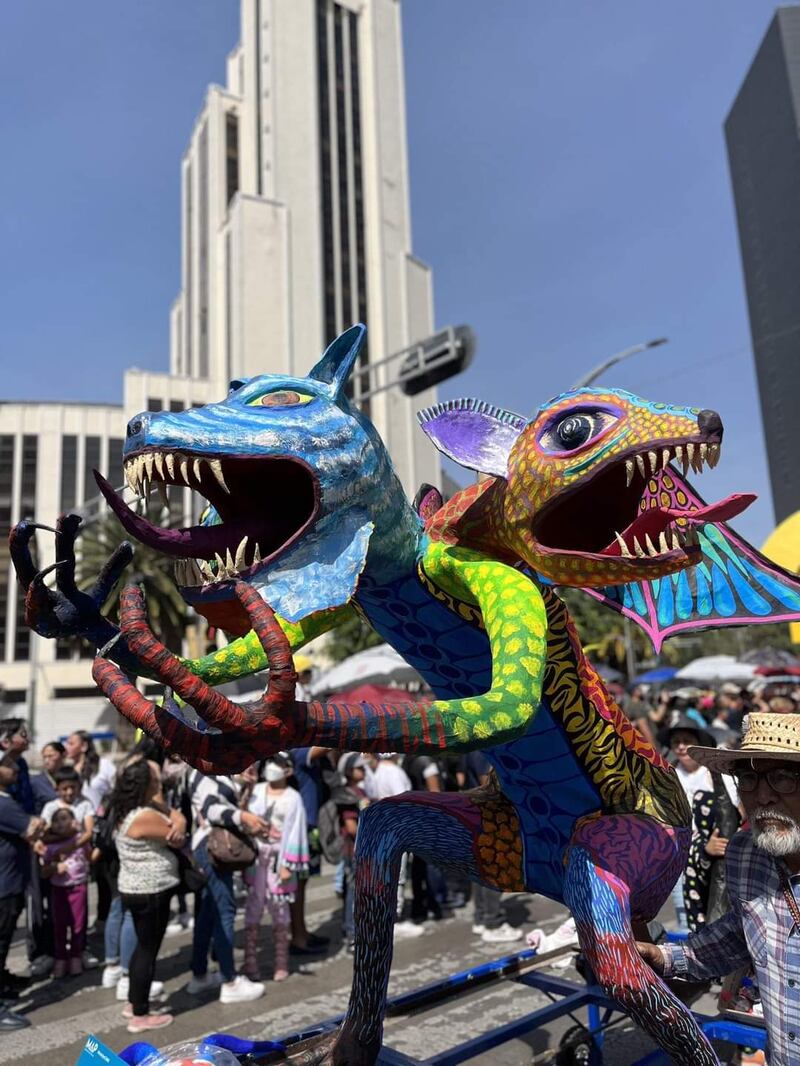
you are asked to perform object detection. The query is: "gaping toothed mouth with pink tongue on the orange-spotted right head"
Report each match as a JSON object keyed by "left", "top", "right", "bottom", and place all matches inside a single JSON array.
[{"left": 532, "top": 441, "right": 755, "bottom": 562}]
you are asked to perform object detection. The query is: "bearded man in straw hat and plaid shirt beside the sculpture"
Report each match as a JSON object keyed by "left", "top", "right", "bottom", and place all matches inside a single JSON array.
[{"left": 637, "top": 713, "right": 800, "bottom": 1066}]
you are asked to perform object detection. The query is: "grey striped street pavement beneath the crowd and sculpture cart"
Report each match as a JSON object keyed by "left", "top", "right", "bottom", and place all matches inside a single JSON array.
[{"left": 0, "top": 875, "right": 725, "bottom": 1066}]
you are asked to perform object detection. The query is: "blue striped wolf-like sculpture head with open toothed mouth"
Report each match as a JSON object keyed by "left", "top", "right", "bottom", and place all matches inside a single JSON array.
[{"left": 95, "top": 326, "right": 421, "bottom": 634}]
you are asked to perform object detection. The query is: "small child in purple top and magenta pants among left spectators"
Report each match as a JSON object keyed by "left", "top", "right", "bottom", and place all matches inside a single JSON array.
[{"left": 36, "top": 801, "right": 89, "bottom": 978}]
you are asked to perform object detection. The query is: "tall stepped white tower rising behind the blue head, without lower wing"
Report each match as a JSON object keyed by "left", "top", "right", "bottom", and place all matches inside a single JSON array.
[{"left": 163, "top": 0, "right": 439, "bottom": 495}]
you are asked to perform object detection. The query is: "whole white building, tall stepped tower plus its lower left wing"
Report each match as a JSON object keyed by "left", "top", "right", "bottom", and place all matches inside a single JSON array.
[{"left": 0, "top": 0, "right": 441, "bottom": 741}]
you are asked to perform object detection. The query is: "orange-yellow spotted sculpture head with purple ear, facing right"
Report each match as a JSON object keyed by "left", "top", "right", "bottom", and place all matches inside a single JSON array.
[{"left": 419, "top": 388, "right": 754, "bottom": 587}]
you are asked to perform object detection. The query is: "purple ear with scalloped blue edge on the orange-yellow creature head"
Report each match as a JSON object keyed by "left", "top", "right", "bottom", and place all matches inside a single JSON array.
[{"left": 417, "top": 400, "right": 528, "bottom": 478}]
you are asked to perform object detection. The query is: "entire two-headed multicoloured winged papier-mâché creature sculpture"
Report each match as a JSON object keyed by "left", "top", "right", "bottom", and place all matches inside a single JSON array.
[{"left": 12, "top": 327, "right": 800, "bottom": 1063}]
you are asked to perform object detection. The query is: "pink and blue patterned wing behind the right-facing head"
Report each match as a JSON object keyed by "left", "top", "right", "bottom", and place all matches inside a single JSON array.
[{"left": 585, "top": 467, "right": 800, "bottom": 651}]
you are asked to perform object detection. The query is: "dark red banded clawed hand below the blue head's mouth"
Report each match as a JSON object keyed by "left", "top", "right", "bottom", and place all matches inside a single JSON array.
[{"left": 92, "top": 582, "right": 307, "bottom": 773}]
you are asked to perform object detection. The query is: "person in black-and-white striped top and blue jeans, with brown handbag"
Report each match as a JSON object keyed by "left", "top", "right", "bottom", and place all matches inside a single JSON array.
[{"left": 187, "top": 770, "right": 269, "bottom": 1003}]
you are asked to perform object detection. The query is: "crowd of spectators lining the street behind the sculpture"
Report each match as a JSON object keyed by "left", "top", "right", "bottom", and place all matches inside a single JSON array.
[{"left": 0, "top": 669, "right": 800, "bottom": 1033}]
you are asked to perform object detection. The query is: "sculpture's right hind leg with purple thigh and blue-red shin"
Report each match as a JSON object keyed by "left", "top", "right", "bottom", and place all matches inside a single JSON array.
[{"left": 564, "top": 814, "right": 719, "bottom": 1066}]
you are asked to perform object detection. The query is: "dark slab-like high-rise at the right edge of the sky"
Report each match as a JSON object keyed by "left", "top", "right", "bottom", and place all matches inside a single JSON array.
[{"left": 725, "top": 6, "right": 800, "bottom": 522}]
